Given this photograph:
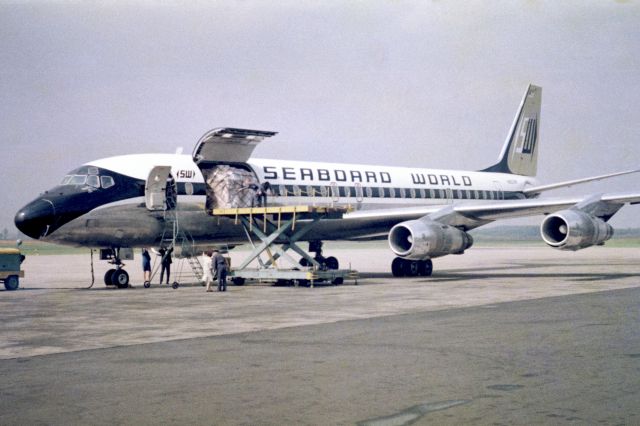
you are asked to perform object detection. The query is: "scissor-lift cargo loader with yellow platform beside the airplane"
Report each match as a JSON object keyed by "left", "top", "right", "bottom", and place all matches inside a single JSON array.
[{"left": 211, "top": 205, "right": 358, "bottom": 287}]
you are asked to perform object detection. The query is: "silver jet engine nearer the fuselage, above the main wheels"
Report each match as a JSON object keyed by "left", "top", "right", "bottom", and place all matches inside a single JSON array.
[{"left": 389, "top": 219, "right": 473, "bottom": 260}]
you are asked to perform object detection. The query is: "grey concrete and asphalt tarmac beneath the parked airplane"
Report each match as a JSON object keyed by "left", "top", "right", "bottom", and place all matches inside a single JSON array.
[{"left": 0, "top": 245, "right": 640, "bottom": 425}]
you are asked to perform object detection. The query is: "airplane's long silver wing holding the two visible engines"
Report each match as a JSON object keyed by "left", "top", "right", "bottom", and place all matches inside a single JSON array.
[{"left": 344, "top": 193, "right": 640, "bottom": 233}]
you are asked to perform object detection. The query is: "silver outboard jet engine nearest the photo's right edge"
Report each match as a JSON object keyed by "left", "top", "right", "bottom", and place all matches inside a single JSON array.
[{"left": 540, "top": 210, "right": 613, "bottom": 251}]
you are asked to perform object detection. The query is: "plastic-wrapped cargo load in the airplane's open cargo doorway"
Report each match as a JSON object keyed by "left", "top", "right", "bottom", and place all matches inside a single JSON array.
[{"left": 206, "top": 165, "right": 258, "bottom": 211}]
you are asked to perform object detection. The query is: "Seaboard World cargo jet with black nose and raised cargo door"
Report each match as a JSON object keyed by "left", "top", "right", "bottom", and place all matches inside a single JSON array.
[{"left": 15, "top": 85, "right": 640, "bottom": 287}]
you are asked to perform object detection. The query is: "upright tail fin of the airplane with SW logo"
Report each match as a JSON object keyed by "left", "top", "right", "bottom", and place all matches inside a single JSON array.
[{"left": 482, "top": 84, "right": 542, "bottom": 176}]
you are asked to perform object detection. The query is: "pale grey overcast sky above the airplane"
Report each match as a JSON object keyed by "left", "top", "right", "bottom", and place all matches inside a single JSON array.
[{"left": 0, "top": 0, "right": 640, "bottom": 235}]
